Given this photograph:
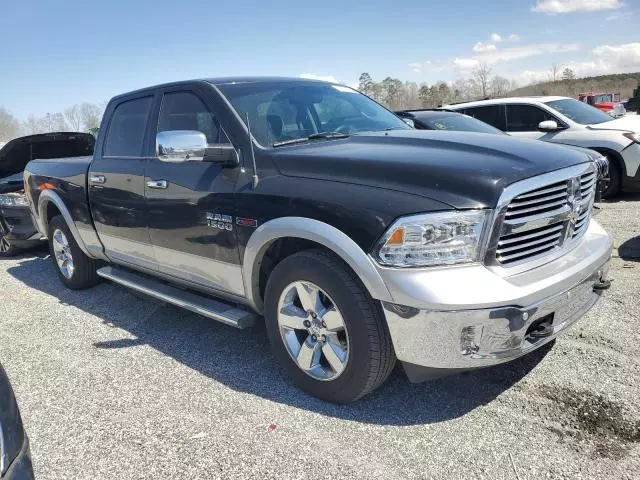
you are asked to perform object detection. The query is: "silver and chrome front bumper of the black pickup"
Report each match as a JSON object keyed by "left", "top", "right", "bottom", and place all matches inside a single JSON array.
[{"left": 379, "top": 220, "right": 612, "bottom": 381}]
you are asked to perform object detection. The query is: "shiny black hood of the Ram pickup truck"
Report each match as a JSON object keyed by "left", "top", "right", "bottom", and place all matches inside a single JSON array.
[{"left": 271, "top": 130, "right": 589, "bottom": 209}]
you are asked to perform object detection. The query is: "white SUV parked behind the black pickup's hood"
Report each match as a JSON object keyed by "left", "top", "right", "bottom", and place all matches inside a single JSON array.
[{"left": 443, "top": 97, "right": 640, "bottom": 197}]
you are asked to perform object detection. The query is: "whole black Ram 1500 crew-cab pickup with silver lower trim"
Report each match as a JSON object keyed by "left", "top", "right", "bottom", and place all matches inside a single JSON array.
[{"left": 25, "top": 78, "right": 612, "bottom": 403}]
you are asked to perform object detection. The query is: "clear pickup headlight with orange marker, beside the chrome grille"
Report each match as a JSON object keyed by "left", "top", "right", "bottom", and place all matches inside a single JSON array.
[{"left": 375, "top": 210, "right": 489, "bottom": 267}]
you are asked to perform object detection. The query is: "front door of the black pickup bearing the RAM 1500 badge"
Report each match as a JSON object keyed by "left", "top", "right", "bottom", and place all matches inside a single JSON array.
[{"left": 146, "top": 86, "right": 244, "bottom": 296}]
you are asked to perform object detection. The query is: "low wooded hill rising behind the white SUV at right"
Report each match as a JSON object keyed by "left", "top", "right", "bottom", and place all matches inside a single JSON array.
[{"left": 506, "top": 72, "right": 640, "bottom": 100}]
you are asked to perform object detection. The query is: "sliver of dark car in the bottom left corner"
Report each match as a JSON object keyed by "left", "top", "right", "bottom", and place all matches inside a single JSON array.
[{"left": 0, "top": 364, "right": 34, "bottom": 480}]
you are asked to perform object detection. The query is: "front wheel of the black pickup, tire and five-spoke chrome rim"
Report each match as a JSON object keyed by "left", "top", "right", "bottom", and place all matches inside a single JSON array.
[{"left": 265, "top": 250, "right": 396, "bottom": 404}]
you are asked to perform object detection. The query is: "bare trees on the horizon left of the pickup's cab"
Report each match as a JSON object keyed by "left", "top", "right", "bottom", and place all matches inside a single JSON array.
[{"left": 0, "top": 102, "right": 104, "bottom": 142}]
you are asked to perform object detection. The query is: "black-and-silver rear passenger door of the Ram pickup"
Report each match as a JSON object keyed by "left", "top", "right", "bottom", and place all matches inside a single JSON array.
[{"left": 88, "top": 93, "right": 155, "bottom": 269}]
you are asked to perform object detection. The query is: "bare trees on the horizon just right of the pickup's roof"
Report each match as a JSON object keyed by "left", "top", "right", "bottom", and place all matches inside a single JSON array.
[{"left": 358, "top": 63, "right": 517, "bottom": 110}]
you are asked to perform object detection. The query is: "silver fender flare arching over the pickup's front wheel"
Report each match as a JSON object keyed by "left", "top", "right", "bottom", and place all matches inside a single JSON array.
[{"left": 242, "top": 217, "right": 392, "bottom": 312}]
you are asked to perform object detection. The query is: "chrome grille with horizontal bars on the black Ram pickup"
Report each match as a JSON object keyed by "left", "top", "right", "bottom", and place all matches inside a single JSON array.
[{"left": 487, "top": 163, "right": 597, "bottom": 267}]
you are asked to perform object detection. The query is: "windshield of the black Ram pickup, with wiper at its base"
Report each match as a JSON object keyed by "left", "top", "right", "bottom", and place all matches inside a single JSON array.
[{"left": 218, "top": 81, "right": 411, "bottom": 147}]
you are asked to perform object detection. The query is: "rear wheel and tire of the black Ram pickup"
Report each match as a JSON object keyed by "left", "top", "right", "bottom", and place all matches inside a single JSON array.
[{"left": 49, "top": 215, "right": 101, "bottom": 290}]
